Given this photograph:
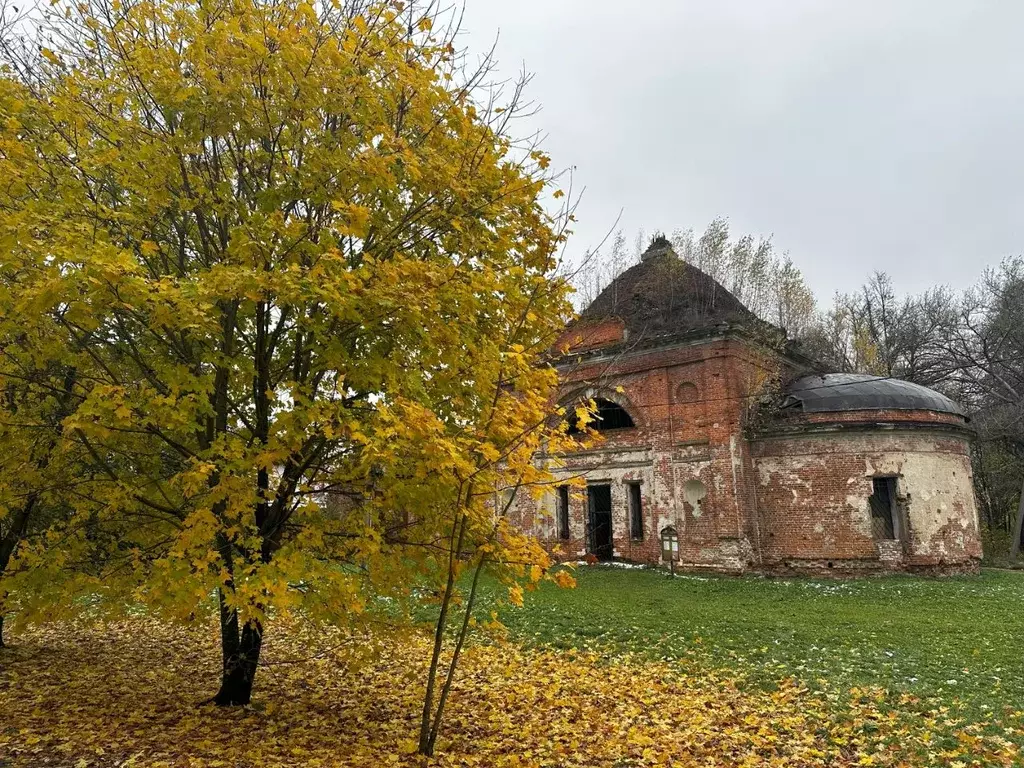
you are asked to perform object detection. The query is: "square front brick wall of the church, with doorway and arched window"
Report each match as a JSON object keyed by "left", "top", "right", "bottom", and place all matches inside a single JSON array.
[{"left": 517, "top": 339, "right": 762, "bottom": 571}]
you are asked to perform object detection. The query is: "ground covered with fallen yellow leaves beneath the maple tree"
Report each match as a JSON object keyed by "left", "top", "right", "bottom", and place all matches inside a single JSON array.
[{"left": 0, "top": 618, "right": 1024, "bottom": 768}]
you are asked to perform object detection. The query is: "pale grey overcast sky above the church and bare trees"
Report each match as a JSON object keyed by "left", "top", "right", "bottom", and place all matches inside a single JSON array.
[{"left": 464, "top": 0, "right": 1024, "bottom": 301}]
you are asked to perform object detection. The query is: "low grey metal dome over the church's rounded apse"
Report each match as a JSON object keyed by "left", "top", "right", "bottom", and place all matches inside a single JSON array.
[{"left": 782, "top": 374, "right": 966, "bottom": 418}]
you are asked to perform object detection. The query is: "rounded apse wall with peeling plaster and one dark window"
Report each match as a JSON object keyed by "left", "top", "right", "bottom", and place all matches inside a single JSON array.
[{"left": 752, "top": 424, "right": 981, "bottom": 569}]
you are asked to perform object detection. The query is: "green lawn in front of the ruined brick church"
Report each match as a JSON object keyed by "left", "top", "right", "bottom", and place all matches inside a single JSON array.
[{"left": 485, "top": 566, "right": 1024, "bottom": 715}]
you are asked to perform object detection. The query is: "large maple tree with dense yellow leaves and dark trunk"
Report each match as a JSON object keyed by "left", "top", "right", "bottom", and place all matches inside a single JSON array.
[{"left": 0, "top": 0, "right": 568, "bottom": 705}]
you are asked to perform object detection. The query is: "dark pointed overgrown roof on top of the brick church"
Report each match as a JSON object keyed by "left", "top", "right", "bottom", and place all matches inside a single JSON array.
[{"left": 577, "top": 237, "right": 764, "bottom": 341}]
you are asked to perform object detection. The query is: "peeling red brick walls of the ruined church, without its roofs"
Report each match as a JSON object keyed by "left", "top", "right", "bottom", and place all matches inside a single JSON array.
[{"left": 511, "top": 328, "right": 981, "bottom": 574}]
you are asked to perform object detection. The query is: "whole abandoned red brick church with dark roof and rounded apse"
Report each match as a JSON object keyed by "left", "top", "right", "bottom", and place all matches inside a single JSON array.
[{"left": 513, "top": 239, "right": 981, "bottom": 573}]
